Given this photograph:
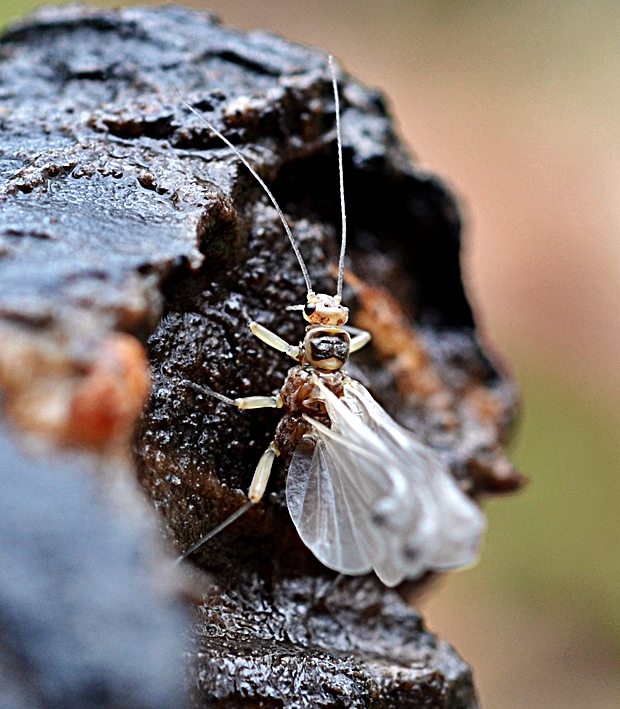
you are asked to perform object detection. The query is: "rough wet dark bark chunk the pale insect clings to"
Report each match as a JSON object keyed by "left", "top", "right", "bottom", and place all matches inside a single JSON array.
[{"left": 0, "top": 6, "right": 521, "bottom": 709}]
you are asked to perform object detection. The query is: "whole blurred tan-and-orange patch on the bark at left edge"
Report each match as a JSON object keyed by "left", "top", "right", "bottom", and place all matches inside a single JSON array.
[{"left": 0, "top": 325, "right": 150, "bottom": 452}]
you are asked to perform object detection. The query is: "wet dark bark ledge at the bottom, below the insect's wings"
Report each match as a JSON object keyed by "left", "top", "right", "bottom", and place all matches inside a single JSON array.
[{"left": 193, "top": 576, "right": 477, "bottom": 708}]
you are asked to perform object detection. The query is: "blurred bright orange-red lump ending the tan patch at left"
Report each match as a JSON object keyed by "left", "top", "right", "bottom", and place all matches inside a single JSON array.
[{"left": 64, "top": 333, "right": 150, "bottom": 448}]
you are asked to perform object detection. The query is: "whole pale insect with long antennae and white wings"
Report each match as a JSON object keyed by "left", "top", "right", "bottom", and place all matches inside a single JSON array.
[{"left": 174, "top": 57, "right": 485, "bottom": 586}]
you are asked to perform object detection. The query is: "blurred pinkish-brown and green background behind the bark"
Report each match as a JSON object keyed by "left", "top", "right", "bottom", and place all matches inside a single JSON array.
[{"left": 0, "top": 0, "right": 620, "bottom": 709}]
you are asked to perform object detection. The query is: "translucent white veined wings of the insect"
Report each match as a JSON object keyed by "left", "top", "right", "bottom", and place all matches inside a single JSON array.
[{"left": 287, "top": 382, "right": 484, "bottom": 586}]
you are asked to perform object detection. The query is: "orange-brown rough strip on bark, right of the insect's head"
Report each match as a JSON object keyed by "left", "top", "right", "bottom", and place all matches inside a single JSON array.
[{"left": 345, "top": 271, "right": 526, "bottom": 495}]
